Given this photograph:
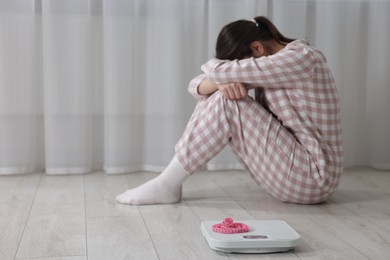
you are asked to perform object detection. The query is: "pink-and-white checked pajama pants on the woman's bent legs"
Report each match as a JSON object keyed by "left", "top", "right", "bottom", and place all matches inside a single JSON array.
[{"left": 176, "top": 91, "right": 330, "bottom": 204}]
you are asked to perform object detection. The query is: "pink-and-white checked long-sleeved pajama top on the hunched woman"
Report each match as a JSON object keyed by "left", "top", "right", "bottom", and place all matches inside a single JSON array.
[{"left": 189, "top": 40, "right": 343, "bottom": 192}]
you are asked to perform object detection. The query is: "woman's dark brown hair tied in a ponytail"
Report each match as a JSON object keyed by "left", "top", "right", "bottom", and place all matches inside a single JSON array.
[{"left": 216, "top": 16, "right": 294, "bottom": 60}]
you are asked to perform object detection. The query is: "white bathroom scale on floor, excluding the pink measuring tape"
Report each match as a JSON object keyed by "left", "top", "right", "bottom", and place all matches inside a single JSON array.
[{"left": 201, "top": 220, "right": 301, "bottom": 253}]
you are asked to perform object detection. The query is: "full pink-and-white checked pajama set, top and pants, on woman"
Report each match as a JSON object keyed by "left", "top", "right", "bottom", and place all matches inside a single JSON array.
[{"left": 176, "top": 40, "right": 343, "bottom": 204}]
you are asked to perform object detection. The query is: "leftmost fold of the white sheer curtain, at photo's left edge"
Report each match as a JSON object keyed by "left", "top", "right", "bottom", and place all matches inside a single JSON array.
[{"left": 0, "top": 1, "right": 43, "bottom": 174}]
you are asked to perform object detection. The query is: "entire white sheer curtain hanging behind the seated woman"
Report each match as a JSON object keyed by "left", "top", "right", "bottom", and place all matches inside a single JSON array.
[{"left": 0, "top": 0, "right": 390, "bottom": 174}]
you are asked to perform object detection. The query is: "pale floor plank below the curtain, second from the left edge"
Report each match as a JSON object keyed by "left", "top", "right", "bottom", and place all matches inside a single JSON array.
[{"left": 17, "top": 175, "right": 86, "bottom": 258}]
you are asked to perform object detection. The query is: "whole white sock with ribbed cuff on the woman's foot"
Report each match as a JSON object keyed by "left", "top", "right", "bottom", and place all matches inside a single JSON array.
[{"left": 116, "top": 155, "right": 190, "bottom": 205}]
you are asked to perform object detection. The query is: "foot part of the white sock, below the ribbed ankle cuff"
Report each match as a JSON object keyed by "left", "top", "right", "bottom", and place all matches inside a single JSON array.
[{"left": 116, "top": 176, "right": 181, "bottom": 205}]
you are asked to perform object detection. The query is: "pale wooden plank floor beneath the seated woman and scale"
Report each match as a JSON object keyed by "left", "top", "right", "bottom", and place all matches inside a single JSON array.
[{"left": 0, "top": 167, "right": 390, "bottom": 260}]
